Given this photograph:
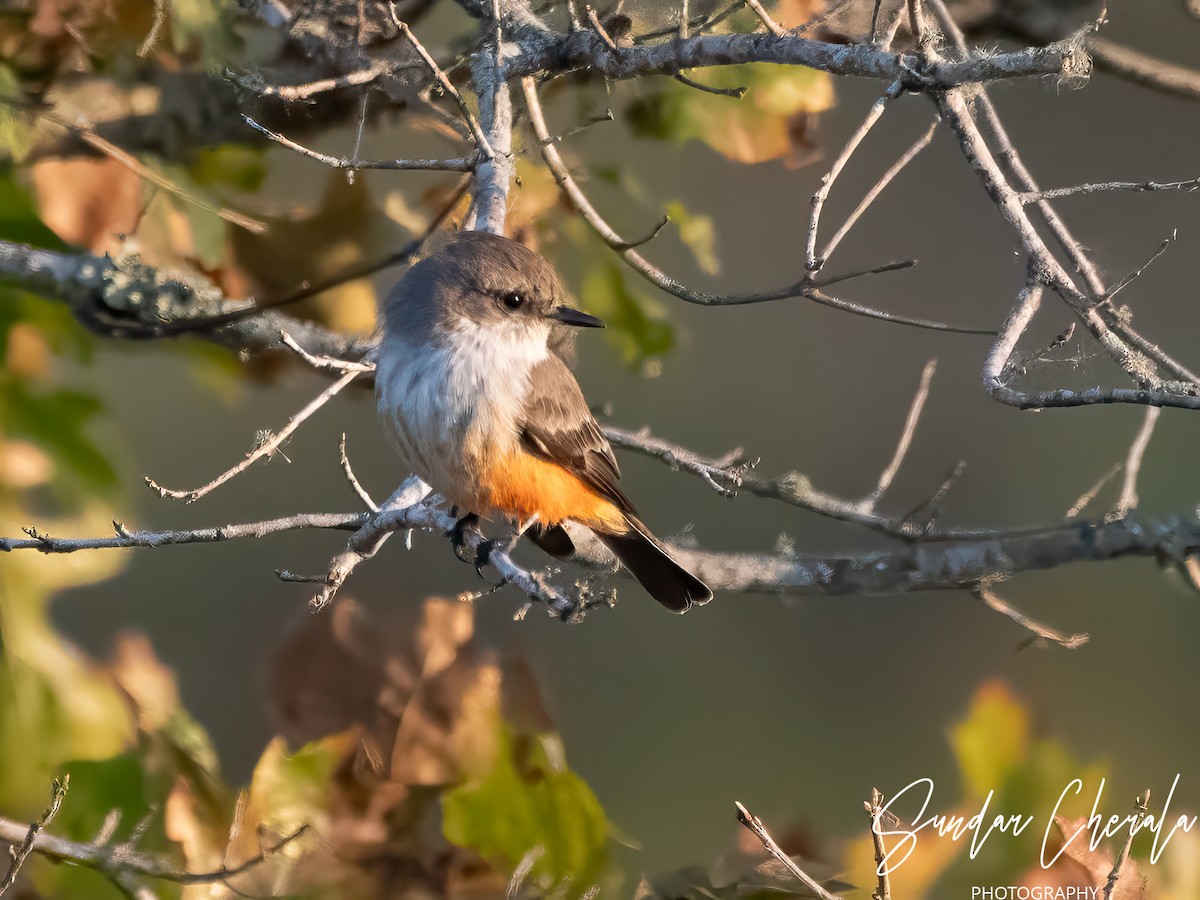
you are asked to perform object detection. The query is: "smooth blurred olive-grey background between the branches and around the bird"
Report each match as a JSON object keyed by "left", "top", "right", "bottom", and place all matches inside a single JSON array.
[{"left": 0, "top": 0, "right": 1200, "bottom": 897}]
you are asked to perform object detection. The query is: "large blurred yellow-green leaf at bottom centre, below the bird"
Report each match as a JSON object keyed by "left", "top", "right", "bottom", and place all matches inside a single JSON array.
[{"left": 442, "top": 719, "right": 608, "bottom": 894}]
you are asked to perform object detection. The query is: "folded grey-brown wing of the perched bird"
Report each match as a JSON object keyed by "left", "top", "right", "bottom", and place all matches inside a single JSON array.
[{"left": 521, "top": 355, "right": 634, "bottom": 512}]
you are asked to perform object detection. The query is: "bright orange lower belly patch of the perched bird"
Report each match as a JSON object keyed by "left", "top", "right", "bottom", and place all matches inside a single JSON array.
[{"left": 479, "top": 450, "right": 629, "bottom": 534}]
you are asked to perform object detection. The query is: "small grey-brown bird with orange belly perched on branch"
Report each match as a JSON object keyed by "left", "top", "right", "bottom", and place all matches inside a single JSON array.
[{"left": 376, "top": 232, "right": 713, "bottom": 612}]
